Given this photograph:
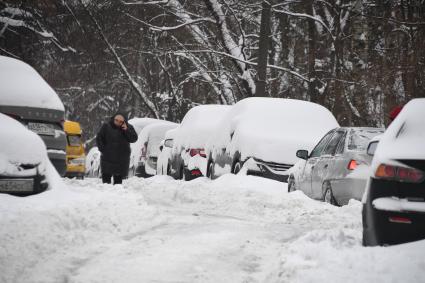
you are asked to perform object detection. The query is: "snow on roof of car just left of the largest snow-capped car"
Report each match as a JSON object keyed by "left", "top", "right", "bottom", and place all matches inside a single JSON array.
[{"left": 174, "top": 104, "right": 231, "bottom": 148}]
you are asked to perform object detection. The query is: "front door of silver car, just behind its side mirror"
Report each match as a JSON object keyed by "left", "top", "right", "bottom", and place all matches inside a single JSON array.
[{"left": 299, "top": 130, "right": 335, "bottom": 196}]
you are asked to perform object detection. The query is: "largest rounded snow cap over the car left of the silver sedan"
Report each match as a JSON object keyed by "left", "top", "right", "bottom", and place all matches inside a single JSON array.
[{"left": 207, "top": 97, "right": 338, "bottom": 164}]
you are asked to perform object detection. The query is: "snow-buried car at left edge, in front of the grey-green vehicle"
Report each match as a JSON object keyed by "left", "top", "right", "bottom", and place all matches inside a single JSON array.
[{"left": 0, "top": 113, "right": 49, "bottom": 195}]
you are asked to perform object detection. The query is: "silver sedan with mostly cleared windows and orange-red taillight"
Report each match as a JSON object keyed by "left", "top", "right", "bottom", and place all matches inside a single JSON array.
[{"left": 288, "top": 127, "right": 384, "bottom": 205}]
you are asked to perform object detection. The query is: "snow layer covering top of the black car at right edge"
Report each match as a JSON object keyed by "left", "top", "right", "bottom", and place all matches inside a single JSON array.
[{"left": 372, "top": 98, "right": 425, "bottom": 171}]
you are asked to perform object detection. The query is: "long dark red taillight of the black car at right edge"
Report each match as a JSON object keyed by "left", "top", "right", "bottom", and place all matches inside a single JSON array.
[{"left": 375, "top": 164, "right": 424, "bottom": 183}]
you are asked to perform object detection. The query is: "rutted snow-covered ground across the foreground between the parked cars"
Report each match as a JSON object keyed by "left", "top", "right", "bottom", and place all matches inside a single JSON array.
[{"left": 0, "top": 175, "right": 425, "bottom": 283}]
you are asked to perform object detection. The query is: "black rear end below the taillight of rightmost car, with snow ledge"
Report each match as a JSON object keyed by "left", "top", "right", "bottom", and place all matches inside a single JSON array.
[{"left": 362, "top": 178, "right": 425, "bottom": 246}]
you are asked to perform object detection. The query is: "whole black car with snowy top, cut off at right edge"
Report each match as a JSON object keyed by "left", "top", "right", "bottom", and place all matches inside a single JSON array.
[{"left": 362, "top": 98, "right": 425, "bottom": 246}]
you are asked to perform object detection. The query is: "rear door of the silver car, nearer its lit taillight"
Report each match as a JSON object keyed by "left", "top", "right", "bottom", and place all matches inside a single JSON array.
[{"left": 311, "top": 129, "right": 345, "bottom": 199}]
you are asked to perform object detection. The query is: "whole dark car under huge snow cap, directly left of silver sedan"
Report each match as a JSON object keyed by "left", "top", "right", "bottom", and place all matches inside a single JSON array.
[{"left": 207, "top": 97, "right": 339, "bottom": 181}]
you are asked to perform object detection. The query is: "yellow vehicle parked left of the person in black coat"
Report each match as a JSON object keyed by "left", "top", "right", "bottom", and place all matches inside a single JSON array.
[{"left": 64, "top": 121, "right": 86, "bottom": 179}]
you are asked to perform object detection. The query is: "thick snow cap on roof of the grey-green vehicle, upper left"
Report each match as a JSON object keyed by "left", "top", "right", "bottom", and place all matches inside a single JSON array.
[{"left": 0, "top": 56, "right": 65, "bottom": 111}]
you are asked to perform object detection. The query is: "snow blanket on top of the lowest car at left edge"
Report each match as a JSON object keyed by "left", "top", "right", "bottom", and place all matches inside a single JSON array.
[{"left": 0, "top": 113, "right": 47, "bottom": 174}]
